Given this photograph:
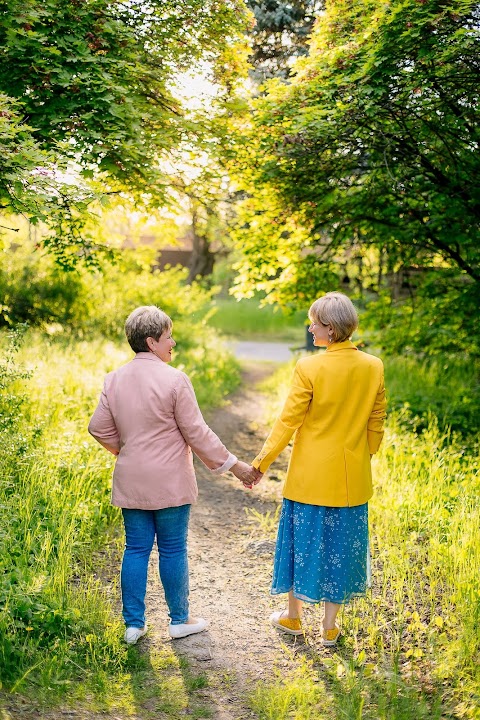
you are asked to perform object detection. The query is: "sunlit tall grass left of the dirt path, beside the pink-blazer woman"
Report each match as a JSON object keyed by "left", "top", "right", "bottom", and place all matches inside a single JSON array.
[{"left": 0, "top": 331, "right": 238, "bottom": 719}]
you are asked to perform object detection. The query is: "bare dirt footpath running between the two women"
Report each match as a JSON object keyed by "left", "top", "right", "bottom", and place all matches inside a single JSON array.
[{"left": 143, "top": 364, "right": 300, "bottom": 720}]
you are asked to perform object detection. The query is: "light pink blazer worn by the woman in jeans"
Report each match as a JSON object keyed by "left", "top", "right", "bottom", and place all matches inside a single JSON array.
[{"left": 88, "top": 352, "right": 237, "bottom": 510}]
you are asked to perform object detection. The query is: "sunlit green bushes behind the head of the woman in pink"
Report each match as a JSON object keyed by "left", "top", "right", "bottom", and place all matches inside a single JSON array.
[{"left": 0, "top": 246, "right": 244, "bottom": 405}]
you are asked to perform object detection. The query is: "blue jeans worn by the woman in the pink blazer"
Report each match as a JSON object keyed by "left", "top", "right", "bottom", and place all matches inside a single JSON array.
[{"left": 121, "top": 505, "right": 190, "bottom": 627}]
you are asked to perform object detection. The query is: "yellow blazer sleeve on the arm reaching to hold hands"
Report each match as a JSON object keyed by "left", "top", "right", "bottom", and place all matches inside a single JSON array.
[{"left": 252, "top": 363, "right": 313, "bottom": 473}]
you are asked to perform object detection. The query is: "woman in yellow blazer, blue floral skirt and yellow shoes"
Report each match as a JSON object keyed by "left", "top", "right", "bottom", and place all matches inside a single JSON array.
[{"left": 252, "top": 292, "right": 385, "bottom": 645}]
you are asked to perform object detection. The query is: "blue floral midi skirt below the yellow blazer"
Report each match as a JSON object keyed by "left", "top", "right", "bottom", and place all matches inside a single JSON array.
[{"left": 271, "top": 498, "right": 370, "bottom": 604}]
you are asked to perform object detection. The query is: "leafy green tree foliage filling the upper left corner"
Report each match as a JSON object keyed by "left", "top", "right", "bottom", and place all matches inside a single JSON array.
[{"left": 0, "top": 0, "right": 247, "bottom": 268}]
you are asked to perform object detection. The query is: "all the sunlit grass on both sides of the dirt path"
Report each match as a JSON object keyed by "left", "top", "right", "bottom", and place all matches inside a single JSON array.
[{"left": 0, "top": 318, "right": 480, "bottom": 720}]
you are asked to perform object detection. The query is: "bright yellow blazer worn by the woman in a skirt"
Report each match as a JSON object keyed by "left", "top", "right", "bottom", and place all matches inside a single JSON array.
[{"left": 253, "top": 340, "right": 386, "bottom": 507}]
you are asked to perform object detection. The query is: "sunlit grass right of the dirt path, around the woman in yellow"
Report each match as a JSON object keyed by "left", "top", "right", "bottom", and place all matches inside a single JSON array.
[{"left": 250, "top": 360, "right": 480, "bottom": 720}]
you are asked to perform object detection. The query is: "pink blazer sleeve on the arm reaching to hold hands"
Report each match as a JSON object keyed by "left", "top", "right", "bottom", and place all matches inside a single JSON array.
[{"left": 174, "top": 375, "right": 237, "bottom": 474}]
